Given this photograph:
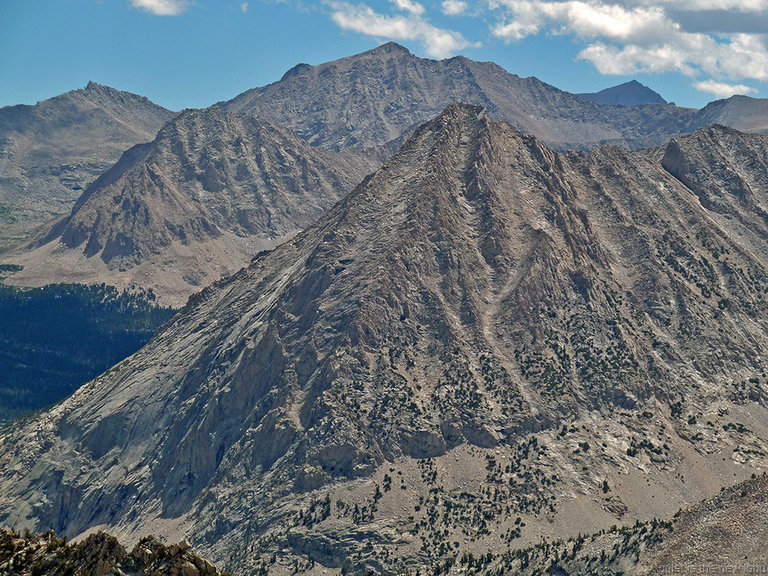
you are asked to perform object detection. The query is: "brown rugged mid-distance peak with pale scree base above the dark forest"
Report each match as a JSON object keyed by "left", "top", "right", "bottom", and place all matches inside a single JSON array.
[{"left": 3, "top": 108, "right": 377, "bottom": 305}]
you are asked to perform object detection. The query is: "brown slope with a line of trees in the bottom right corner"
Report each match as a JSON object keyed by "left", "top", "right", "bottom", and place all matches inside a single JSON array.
[{"left": 438, "top": 474, "right": 768, "bottom": 576}]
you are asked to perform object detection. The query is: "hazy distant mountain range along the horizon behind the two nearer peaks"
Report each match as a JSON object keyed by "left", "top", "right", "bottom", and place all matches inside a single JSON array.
[{"left": 6, "top": 43, "right": 768, "bottom": 258}]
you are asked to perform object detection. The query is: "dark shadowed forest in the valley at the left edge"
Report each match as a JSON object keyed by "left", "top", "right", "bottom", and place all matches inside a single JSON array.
[{"left": 0, "top": 284, "right": 176, "bottom": 422}]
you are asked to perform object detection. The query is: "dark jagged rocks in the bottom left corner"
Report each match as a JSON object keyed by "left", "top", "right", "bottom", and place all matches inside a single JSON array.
[{"left": 0, "top": 530, "right": 223, "bottom": 576}]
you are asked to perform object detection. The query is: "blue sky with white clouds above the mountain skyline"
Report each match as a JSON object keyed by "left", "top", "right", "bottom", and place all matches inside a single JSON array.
[{"left": 0, "top": 0, "right": 768, "bottom": 110}]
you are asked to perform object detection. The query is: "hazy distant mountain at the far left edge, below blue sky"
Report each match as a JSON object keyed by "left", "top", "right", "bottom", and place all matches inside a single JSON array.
[{"left": 0, "top": 82, "right": 175, "bottom": 249}]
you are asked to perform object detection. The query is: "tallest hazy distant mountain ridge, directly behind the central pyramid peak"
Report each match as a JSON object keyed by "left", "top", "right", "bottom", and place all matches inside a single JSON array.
[{"left": 222, "top": 43, "right": 768, "bottom": 151}]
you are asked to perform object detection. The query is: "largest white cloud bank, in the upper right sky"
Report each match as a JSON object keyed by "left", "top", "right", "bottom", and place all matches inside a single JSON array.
[{"left": 488, "top": 0, "right": 768, "bottom": 86}]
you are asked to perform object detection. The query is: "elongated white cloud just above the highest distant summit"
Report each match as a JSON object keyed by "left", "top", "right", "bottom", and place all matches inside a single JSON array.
[{"left": 326, "top": 0, "right": 475, "bottom": 58}]
